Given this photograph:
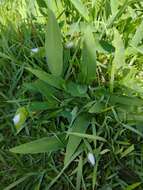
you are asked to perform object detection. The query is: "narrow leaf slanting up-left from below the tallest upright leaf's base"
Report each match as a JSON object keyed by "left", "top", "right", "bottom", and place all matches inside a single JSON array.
[{"left": 27, "top": 68, "right": 65, "bottom": 89}]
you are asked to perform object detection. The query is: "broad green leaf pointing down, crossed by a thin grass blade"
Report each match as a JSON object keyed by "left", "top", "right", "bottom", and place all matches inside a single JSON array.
[{"left": 64, "top": 115, "right": 89, "bottom": 165}]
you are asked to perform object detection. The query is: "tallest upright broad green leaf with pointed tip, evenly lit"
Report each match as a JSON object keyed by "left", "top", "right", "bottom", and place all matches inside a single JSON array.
[{"left": 45, "top": 9, "right": 63, "bottom": 76}]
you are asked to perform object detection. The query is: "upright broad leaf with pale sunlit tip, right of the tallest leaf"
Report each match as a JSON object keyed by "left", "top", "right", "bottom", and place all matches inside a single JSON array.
[{"left": 81, "top": 27, "right": 96, "bottom": 84}]
